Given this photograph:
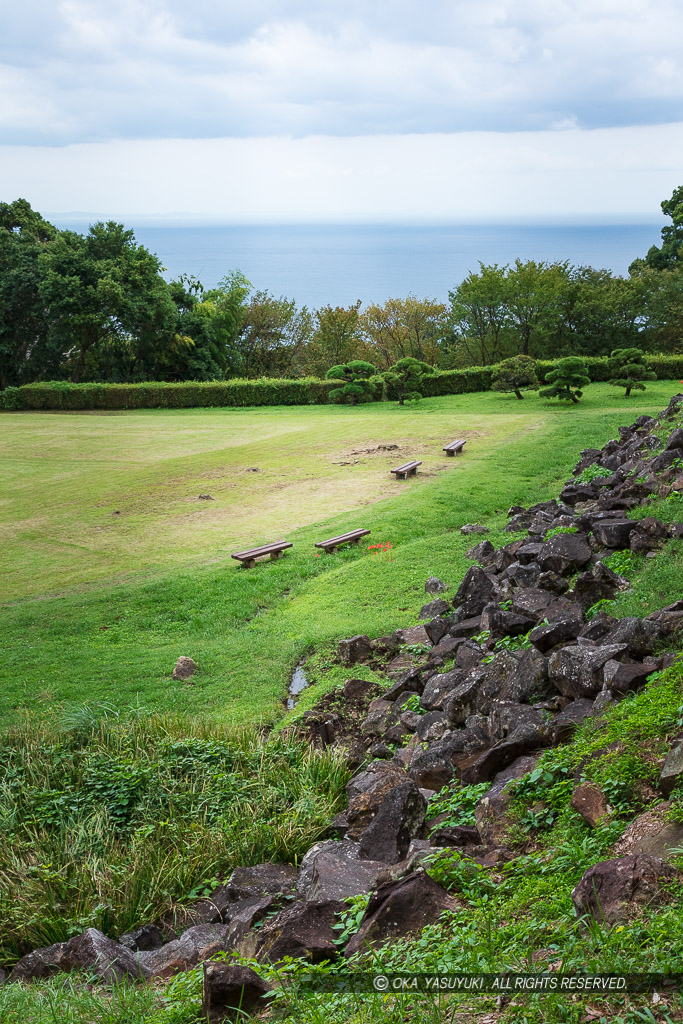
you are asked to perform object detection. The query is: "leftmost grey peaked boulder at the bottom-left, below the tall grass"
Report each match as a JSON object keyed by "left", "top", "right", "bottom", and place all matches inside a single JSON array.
[{"left": 10, "top": 928, "right": 150, "bottom": 983}]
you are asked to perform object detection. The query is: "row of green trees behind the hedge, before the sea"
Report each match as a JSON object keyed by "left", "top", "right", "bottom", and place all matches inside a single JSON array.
[{"left": 0, "top": 186, "right": 683, "bottom": 389}]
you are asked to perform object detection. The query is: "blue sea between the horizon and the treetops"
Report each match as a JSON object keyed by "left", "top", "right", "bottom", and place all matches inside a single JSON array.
[{"left": 55, "top": 218, "right": 661, "bottom": 308}]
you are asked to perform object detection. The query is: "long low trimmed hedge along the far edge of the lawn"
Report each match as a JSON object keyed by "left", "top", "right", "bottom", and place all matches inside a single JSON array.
[{"left": 0, "top": 355, "right": 683, "bottom": 411}]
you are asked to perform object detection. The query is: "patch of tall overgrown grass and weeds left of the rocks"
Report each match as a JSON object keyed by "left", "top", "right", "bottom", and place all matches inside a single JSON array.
[{"left": 0, "top": 705, "right": 347, "bottom": 963}]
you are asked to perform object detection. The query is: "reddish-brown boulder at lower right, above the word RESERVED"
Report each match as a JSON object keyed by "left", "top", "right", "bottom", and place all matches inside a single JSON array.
[{"left": 571, "top": 853, "right": 677, "bottom": 925}]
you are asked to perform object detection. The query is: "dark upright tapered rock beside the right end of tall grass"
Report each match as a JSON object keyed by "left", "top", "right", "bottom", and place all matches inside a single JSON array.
[{"left": 359, "top": 779, "right": 427, "bottom": 864}]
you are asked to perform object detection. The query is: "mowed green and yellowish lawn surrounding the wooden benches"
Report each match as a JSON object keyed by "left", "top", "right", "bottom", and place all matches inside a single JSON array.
[{"left": 0, "top": 382, "right": 678, "bottom": 724}]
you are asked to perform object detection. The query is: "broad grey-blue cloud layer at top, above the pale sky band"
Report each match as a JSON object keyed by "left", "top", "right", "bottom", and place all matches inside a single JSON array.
[{"left": 0, "top": 0, "right": 683, "bottom": 145}]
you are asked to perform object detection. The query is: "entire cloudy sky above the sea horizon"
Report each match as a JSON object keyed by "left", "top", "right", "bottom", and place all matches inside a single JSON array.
[{"left": 0, "top": 0, "right": 683, "bottom": 222}]
